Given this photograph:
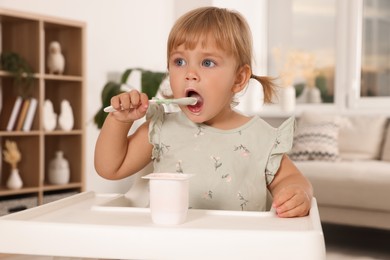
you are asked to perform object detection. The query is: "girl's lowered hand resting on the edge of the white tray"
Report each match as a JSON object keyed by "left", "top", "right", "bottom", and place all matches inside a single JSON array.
[{"left": 272, "top": 185, "right": 311, "bottom": 218}]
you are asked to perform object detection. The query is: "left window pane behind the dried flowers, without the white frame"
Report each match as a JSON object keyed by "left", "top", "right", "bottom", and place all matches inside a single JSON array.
[{"left": 268, "top": 0, "right": 336, "bottom": 103}]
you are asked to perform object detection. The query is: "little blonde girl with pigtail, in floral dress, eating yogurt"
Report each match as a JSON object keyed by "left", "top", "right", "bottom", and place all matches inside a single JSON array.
[{"left": 95, "top": 7, "right": 312, "bottom": 217}]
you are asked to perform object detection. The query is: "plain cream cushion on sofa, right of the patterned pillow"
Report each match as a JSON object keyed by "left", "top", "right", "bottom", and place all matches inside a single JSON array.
[{"left": 339, "top": 115, "right": 387, "bottom": 160}]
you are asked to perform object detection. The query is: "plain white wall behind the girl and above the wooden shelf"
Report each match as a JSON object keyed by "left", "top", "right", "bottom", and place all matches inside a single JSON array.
[{"left": 0, "top": 0, "right": 266, "bottom": 192}]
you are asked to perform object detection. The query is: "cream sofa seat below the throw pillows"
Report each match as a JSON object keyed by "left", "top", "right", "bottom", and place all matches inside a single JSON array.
[{"left": 295, "top": 160, "right": 390, "bottom": 211}]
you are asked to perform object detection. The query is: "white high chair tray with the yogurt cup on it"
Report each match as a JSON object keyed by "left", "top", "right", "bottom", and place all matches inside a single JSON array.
[{"left": 0, "top": 192, "right": 325, "bottom": 260}]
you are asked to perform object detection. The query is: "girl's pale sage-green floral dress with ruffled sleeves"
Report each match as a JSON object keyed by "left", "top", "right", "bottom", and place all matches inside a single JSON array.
[{"left": 149, "top": 106, "right": 295, "bottom": 211}]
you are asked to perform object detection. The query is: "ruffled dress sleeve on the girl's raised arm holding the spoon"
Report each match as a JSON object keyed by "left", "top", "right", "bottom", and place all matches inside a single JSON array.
[{"left": 146, "top": 104, "right": 165, "bottom": 161}]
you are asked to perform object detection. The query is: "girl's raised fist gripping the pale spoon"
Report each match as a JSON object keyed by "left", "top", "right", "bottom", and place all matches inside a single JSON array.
[{"left": 111, "top": 90, "right": 149, "bottom": 123}]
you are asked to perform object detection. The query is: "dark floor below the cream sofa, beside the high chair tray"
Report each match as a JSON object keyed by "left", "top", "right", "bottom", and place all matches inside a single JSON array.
[{"left": 0, "top": 220, "right": 390, "bottom": 260}]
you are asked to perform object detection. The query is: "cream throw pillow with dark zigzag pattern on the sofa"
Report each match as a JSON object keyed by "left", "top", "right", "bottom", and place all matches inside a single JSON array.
[{"left": 289, "top": 112, "right": 340, "bottom": 161}]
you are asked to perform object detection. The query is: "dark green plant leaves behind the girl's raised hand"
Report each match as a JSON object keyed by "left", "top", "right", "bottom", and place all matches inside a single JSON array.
[{"left": 94, "top": 68, "right": 167, "bottom": 129}]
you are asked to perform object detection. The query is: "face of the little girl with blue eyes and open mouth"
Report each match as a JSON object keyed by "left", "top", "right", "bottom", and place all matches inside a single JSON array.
[{"left": 168, "top": 39, "right": 247, "bottom": 126}]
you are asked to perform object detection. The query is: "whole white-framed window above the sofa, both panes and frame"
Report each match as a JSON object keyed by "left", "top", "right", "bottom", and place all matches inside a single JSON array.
[{"left": 267, "top": 0, "right": 390, "bottom": 109}]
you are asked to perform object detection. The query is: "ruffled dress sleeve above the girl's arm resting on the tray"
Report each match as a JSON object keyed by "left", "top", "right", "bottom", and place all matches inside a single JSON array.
[{"left": 265, "top": 117, "right": 295, "bottom": 185}]
